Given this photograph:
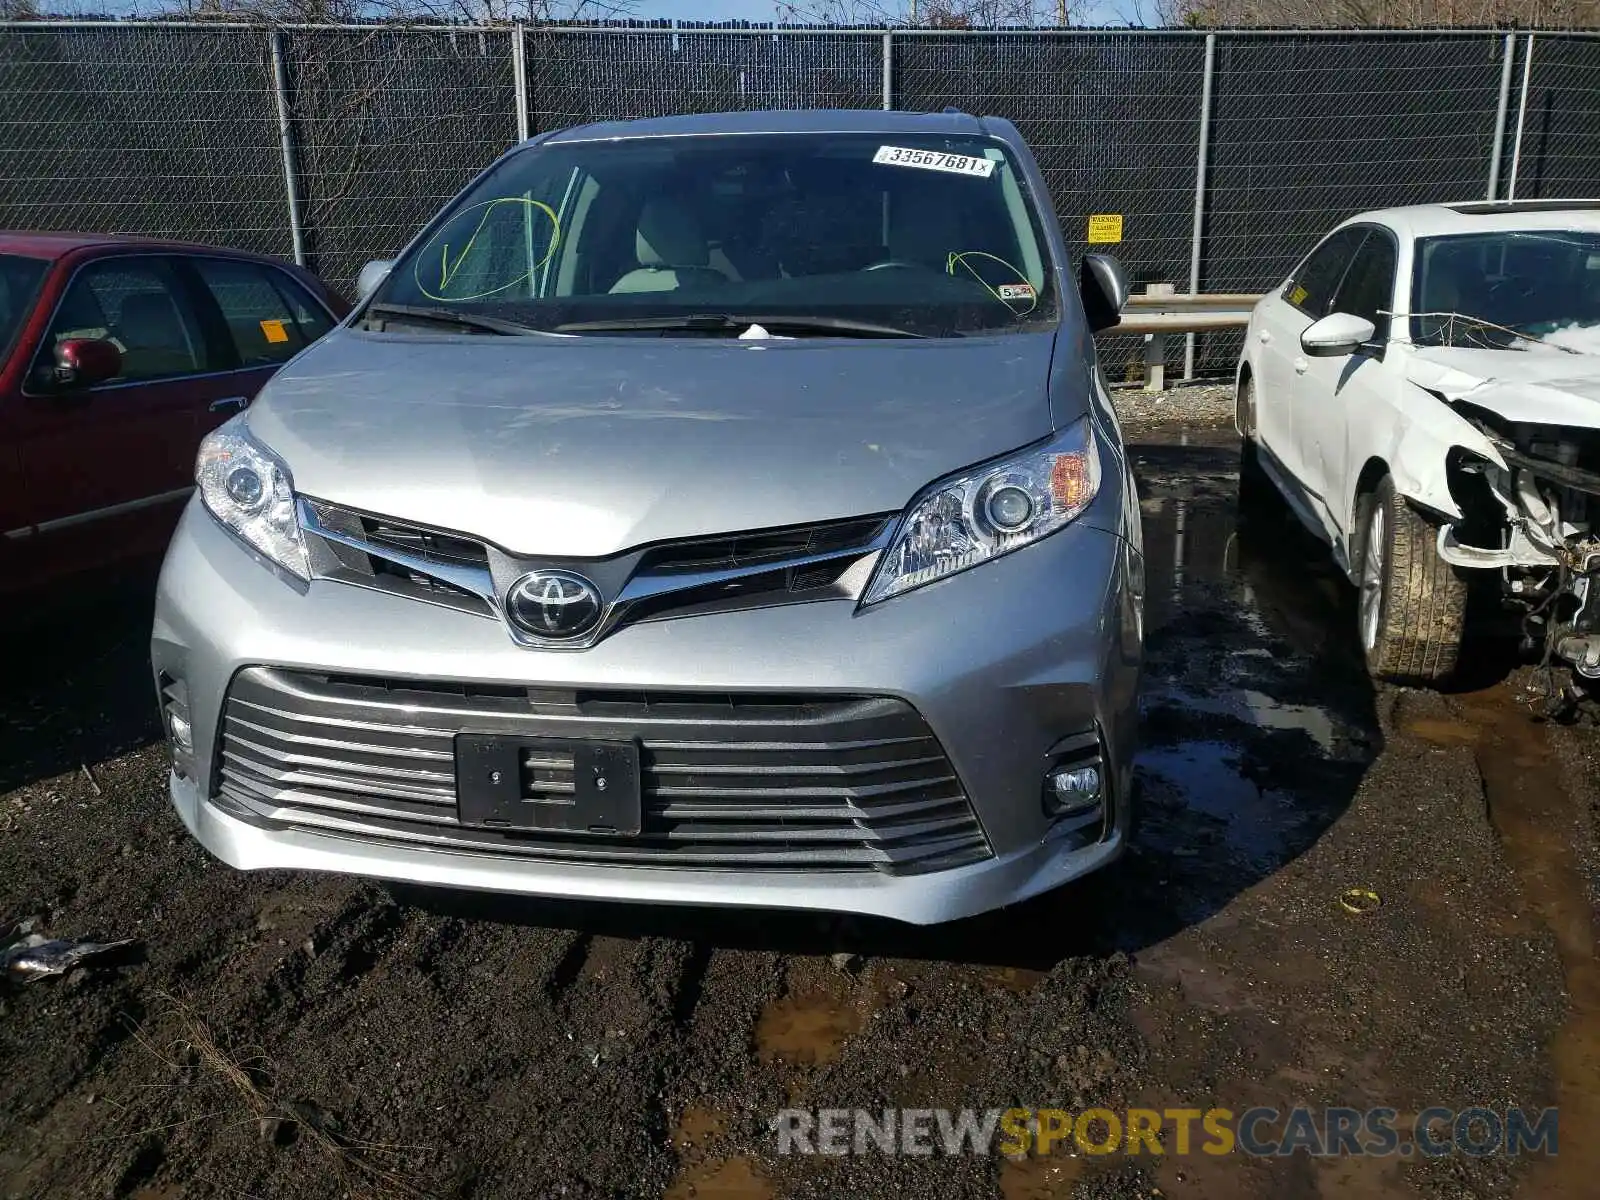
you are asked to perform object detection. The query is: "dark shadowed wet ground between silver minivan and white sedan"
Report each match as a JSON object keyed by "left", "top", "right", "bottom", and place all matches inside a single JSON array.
[{"left": 1131, "top": 430, "right": 1379, "bottom": 902}]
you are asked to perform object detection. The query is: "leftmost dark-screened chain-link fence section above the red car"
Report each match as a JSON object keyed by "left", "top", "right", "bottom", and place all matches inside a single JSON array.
[{"left": 0, "top": 24, "right": 293, "bottom": 254}]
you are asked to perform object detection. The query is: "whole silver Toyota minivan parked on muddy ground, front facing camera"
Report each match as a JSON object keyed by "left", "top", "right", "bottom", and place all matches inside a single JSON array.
[{"left": 152, "top": 112, "right": 1142, "bottom": 923}]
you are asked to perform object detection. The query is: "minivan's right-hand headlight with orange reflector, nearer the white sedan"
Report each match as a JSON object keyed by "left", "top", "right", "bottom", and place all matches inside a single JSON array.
[{"left": 861, "top": 419, "right": 1099, "bottom": 606}]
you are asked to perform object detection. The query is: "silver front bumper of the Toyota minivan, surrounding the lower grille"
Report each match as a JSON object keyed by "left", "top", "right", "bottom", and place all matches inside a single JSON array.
[{"left": 152, "top": 506, "right": 1141, "bottom": 923}]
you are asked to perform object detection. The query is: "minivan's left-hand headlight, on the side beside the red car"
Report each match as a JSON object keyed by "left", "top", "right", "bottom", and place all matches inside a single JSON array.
[{"left": 195, "top": 414, "right": 310, "bottom": 579}]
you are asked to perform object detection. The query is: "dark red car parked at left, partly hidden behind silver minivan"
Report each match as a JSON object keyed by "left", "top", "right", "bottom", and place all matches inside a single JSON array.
[{"left": 0, "top": 232, "right": 347, "bottom": 598}]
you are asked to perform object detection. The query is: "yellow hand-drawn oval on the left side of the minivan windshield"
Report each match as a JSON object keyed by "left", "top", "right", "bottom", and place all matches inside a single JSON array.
[{"left": 411, "top": 195, "right": 562, "bottom": 304}]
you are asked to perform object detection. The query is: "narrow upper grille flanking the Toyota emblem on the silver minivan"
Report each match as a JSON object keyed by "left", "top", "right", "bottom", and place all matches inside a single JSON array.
[{"left": 299, "top": 498, "right": 894, "bottom": 650}]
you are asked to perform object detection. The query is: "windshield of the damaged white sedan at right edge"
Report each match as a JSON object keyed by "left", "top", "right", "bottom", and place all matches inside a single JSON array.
[{"left": 1411, "top": 229, "right": 1600, "bottom": 354}]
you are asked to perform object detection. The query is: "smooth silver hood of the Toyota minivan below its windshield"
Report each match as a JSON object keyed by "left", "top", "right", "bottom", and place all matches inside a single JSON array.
[{"left": 248, "top": 330, "right": 1062, "bottom": 557}]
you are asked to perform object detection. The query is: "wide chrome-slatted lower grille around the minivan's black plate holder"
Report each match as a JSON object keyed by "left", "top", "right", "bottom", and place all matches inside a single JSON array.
[{"left": 214, "top": 667, "right": 990, "bottom": 874}]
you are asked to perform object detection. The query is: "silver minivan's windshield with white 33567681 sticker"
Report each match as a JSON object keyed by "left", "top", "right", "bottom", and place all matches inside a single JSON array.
[{"left": 371, "top": 133, "right": 1056, "bottom": 338}]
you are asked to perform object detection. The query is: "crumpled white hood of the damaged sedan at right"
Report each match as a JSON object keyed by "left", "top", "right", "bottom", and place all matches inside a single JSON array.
[{"left": 1406, "top": 346, "right": 1600, "bottom": 429}]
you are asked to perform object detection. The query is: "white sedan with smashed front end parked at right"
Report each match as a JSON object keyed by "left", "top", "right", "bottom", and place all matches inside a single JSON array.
[{"left": 1237, "top": 200, "right": 1600, "bottom": 683}]
